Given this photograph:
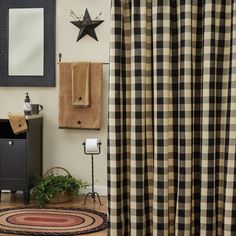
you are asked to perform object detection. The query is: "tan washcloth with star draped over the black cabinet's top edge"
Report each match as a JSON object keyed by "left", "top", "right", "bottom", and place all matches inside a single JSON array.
[{"left": 8, "top": 113, "right": 28, "bottom": 134}]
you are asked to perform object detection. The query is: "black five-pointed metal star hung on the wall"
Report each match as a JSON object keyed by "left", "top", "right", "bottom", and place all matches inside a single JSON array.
[{"left": 71, "top": 8, "right": 103, "bottom": 42}]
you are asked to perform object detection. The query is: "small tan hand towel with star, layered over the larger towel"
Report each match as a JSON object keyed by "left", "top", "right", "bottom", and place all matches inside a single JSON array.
[{"left": 71, "top": 62, "right": 90, "bottom": 107}]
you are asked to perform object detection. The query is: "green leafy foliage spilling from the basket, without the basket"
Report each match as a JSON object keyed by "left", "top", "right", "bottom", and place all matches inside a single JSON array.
[{"left": 33, "top": 173, "right": 89, "bottom": 206}]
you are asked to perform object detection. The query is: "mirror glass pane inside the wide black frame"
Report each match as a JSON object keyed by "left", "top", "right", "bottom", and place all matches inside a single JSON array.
[{"left": 8, "top": 8, "right": 44, "bottom": 76}]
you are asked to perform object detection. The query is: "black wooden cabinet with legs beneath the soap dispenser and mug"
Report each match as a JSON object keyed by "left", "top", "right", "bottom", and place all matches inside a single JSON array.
[{"left": 0, "top": 116, "right": 43, "bottom": 204}]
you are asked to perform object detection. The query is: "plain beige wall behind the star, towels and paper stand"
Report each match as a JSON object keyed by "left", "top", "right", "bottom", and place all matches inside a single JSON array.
[{"left": 0, "top": 0, "right": 109, "bottom": 194}]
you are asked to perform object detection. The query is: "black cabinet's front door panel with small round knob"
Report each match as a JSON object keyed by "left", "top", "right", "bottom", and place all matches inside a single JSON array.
[{"left": 0, "top": 139, "right": 27, "bottom": 181}]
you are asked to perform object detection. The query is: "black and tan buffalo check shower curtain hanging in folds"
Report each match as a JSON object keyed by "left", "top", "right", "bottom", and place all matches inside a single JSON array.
[{"left": 108, "top": 0, "right": 236, "bottom": 236}]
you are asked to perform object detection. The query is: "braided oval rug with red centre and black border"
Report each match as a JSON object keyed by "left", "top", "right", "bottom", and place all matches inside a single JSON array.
[{"left": 0, "top": 207, "right": 107, "bottom": 235}]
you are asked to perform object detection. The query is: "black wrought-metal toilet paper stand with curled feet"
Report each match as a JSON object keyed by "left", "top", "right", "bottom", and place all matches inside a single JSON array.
[{"left": 83, "top": 141, "right": 102, "bottom": 206}]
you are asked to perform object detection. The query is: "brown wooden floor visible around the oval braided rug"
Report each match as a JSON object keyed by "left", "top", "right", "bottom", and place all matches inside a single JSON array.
[{"left": 0, "top": 192, "right": 107, "bottom": 236}]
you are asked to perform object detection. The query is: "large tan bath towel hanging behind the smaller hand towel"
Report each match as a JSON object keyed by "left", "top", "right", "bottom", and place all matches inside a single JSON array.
[{"left": 59, "top": 63, "right": 103, "bottom": 129}]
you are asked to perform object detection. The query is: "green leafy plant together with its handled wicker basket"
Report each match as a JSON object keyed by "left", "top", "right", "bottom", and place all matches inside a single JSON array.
[{"left": 33, "top": 167, "right": 89, "bottom": 206}]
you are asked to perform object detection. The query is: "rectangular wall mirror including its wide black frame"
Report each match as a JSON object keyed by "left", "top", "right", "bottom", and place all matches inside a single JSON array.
[{"left": 0, "top": 0, "right": 56, "bottom": 87}]
